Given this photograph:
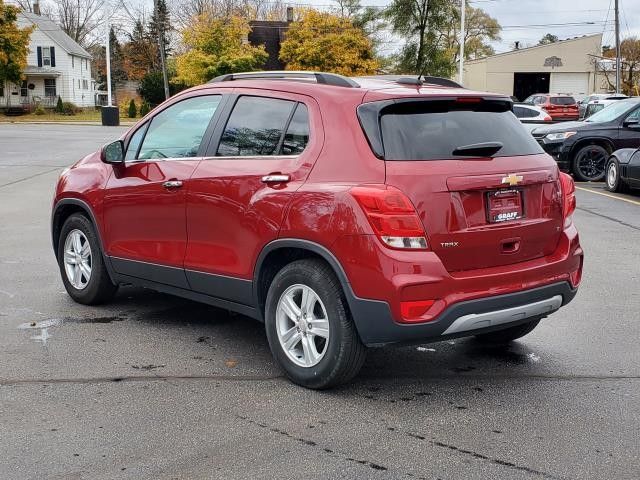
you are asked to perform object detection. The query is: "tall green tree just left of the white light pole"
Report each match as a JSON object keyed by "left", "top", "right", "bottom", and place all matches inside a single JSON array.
[{"left": 385, "top": 0, "right": 455, "bottom": 77}]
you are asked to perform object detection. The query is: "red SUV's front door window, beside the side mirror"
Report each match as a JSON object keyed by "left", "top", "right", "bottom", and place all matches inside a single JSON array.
[{"left": 137, "top": 95, "right": 221, "bottom": 160}]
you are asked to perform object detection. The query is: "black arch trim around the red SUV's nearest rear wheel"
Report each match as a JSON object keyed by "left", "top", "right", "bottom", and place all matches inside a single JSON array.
[{"left": 253, "top": 238, "right": 355, "bottom": 321}]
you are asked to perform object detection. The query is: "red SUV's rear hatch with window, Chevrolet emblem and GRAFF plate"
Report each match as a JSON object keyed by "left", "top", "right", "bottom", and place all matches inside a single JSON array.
[{"left": 358, "top": 97, "right": 562, "bottom": 272}]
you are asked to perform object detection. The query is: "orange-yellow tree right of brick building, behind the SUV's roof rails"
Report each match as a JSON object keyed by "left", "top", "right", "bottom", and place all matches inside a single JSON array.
[{"left": 280, "top": 9, "right": 378, "bottom": 76}]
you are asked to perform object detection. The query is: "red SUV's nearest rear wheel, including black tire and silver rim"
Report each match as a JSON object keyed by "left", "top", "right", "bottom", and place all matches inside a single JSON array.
[{"left": 265, "top": 259, "right": 366, "bottom": 389}]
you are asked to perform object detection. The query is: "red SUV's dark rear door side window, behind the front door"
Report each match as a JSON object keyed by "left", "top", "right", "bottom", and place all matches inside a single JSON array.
[{"left": 217, "top": 96, "right": 300, "bottom": 157}]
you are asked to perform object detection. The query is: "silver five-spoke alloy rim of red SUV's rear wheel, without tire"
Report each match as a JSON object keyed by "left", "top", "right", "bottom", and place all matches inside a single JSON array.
[{"left": 276, "top": 284, "right": 329, "bottom": 367}]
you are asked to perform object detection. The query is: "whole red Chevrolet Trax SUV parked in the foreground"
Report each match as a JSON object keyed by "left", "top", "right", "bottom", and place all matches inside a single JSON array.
[{"left": 52, "top": 72, "right": 583, "bottom": 388}]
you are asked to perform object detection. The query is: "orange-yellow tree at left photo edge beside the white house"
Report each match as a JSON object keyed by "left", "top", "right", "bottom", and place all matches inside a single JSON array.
[{"left": 0, "top": 0, "right": 33, "bottom": 89}]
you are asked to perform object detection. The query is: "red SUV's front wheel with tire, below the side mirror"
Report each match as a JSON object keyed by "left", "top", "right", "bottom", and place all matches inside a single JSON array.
[{"left": 58, "top": 213, "right": 118, "bottom": 305}]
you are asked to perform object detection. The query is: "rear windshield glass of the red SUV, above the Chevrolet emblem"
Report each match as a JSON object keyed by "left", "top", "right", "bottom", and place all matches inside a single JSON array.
[{"left": 368, "top": 101, "right": 543, "bottom": 160}]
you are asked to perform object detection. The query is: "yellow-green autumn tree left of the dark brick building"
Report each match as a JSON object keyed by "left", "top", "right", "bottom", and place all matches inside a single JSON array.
[{"left": 174, "top": 13, "right": 268, "bottom": 86}]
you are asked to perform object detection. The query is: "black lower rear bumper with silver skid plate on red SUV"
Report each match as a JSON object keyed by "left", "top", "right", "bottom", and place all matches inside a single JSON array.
[{"left": 349, "top": 282, "right": 577, "bottom": 346}]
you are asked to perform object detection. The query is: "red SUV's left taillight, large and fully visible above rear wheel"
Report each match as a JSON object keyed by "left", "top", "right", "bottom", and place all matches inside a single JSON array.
[{"left": 351, "top": 185, "right": 427, "bottom": 250}]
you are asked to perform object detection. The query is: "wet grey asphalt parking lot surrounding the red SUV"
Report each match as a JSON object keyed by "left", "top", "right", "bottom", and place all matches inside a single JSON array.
[{"left": 0, "top": 124, "right": 640, "bottom": 480}]
